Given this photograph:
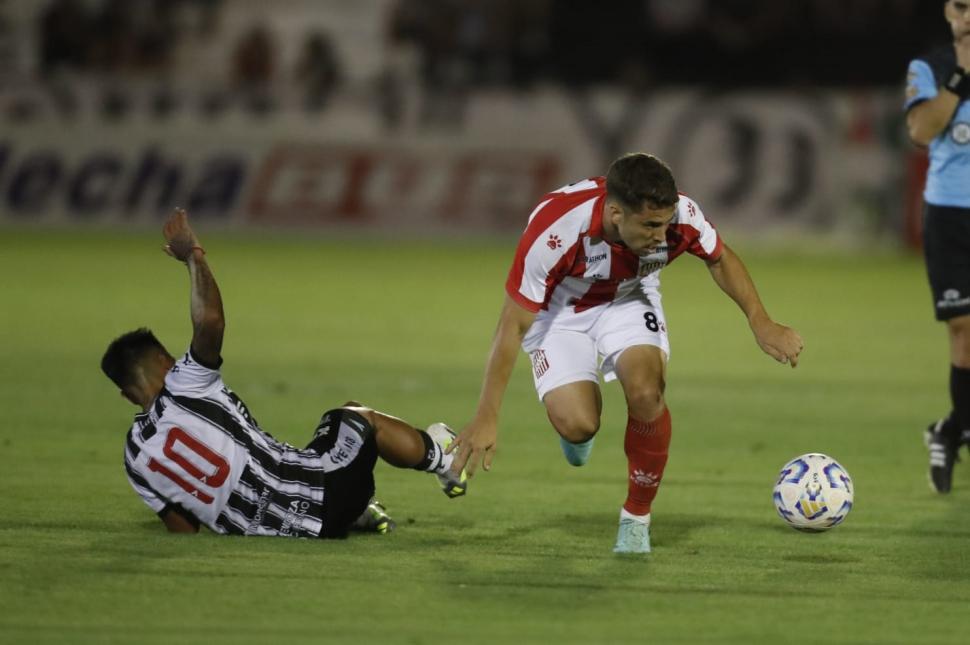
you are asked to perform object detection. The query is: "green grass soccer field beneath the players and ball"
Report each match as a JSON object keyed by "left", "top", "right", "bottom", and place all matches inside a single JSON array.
[{"left": 0, "top": 225, "right": 970, "bottom": 644}]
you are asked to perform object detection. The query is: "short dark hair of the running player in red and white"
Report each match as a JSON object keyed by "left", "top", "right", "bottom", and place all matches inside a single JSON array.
[{"left": 606, "top": 152, "right": 678, "bottom": 212}]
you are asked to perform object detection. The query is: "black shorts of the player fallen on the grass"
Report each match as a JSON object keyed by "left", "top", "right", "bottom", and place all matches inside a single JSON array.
[{"left": 307, "top": 408, "right": 377, "bottom": 538}]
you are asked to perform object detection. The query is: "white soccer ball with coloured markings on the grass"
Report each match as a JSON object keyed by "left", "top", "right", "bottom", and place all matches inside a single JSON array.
[{"left": 773, "top": 452, "right": 853, "bottom": 531}]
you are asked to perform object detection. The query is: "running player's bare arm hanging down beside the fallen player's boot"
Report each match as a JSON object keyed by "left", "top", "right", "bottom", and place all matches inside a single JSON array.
[{"left": 448, "top": 296, "right": 535, "bottom": 477}]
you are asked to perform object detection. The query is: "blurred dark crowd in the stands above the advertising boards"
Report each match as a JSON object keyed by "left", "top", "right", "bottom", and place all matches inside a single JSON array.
[{"left": 0, "top": 0, "right": 946, "bottom": 123}]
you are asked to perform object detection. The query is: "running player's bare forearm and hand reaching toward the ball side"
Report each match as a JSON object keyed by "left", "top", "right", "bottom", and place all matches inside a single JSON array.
[{"left": 707, "top": 245, "right": 805, "bottom": 367}]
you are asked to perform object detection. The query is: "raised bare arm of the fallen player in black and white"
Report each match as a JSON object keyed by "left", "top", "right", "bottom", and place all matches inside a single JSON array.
[{"left": 162, "top": 208, "right": 226, "bottom": 365}]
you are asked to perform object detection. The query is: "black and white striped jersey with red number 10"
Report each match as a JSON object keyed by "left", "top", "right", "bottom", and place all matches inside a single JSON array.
[{"left": 118, "top": 350, "right": 360, "bottom": 537}]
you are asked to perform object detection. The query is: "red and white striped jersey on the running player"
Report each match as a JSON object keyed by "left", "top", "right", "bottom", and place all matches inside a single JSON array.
[{"left": 505, "top": 177, "right": 724, "bottom": 313}]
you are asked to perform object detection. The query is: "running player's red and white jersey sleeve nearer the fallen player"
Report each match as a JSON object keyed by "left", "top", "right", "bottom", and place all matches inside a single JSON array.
[{"left": 505, "top": 218, "right": 574, "bottom": 313}]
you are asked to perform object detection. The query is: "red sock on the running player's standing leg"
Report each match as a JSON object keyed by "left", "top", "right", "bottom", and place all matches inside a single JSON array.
[{"left": 623, "top": 407, "right": 670, "bottom": 515}]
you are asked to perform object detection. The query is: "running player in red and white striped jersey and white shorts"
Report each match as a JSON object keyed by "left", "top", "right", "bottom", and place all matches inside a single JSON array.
[{"left": 450, "top": 153, "right": 803, "bottom": 553}]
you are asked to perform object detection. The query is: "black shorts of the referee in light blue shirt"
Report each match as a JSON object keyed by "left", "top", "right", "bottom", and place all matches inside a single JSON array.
[{"left": 923, "top": 204, "right": 970, "bottom": 320}]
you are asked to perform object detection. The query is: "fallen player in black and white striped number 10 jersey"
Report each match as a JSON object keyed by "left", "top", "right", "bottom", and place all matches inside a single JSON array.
[{"left": 101, "top": 210, "right": 467, "bottom": 537}]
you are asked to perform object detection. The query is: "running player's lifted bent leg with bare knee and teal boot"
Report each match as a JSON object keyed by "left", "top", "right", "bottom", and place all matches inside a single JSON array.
[{"left": 542, "top": 381, "right": 603, "bottom": 466}]
